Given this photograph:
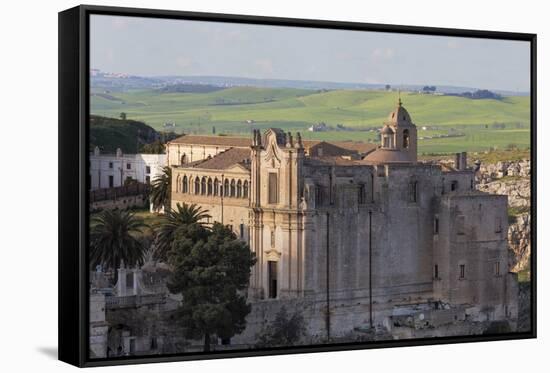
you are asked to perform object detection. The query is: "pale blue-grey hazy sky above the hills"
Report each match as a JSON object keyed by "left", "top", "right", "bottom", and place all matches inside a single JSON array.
[{"left": 90, "top": 15, "right": 530, "bottom": 92}]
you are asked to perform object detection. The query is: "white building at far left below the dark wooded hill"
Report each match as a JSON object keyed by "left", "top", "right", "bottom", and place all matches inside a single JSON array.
[{"left": 90, "top": 147, "right": 167, "bottom": 190}]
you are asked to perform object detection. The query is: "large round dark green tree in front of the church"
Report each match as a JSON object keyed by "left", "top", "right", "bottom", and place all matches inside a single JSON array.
[{"left": 167, "top": 223, "right": 256, "bottom": 351}]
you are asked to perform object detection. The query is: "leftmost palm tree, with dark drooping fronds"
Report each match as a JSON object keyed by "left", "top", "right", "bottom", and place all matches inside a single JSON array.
[{"left": 90, "top": 209, "right": 147, "bottom": 283}]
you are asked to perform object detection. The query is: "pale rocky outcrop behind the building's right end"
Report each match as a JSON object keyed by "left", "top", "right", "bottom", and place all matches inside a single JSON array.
[{"left": 476, "top": 160, "right": 531, "bottom": 272}]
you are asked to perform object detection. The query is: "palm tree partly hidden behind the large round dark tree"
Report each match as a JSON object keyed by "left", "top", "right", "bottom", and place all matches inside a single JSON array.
[{"left": 155, "top": 203, "right": 211, "bottom": 261}]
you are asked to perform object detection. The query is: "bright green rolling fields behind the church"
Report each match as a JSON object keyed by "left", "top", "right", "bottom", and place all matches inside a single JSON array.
[{"left": 91, "top": 87, "right": 530, "bottom": 154}]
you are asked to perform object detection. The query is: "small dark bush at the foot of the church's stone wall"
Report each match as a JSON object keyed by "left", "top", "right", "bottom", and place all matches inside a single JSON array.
[{"left": 257, "top": 306, "right": 305, "bottom": 348}]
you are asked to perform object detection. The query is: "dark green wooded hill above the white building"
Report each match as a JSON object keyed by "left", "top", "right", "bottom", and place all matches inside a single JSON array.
[{"left": 90, "top": 115, "right": 159, "bottom": 154}]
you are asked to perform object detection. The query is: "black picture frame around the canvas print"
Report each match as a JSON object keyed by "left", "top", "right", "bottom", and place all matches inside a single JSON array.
[{"left": 58, "top": 5, "right": 537, "bottom": 367}]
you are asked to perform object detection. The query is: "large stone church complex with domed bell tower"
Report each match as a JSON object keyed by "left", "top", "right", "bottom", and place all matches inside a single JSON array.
[{"left": 167, "top": 102, "right": 517, "bottom": 335}]
